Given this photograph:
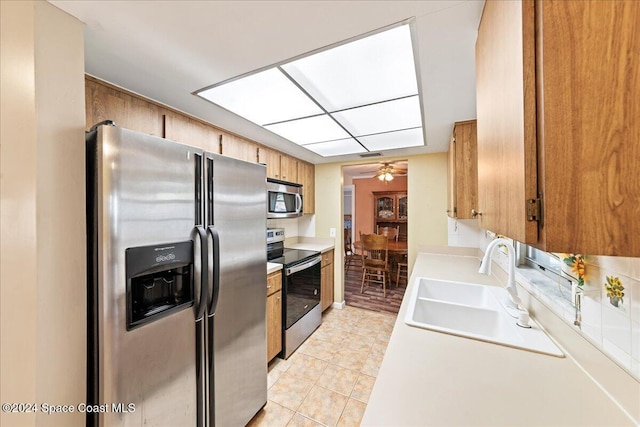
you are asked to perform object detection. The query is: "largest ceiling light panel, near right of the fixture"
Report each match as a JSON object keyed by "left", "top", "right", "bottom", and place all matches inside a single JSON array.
[{"left": 282, "top": 25, "right": 418, "bottom": 112}]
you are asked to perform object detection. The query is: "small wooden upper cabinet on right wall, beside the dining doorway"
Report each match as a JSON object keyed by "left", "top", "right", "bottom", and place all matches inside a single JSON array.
[{"left": 447, "top": 120, "right": 478, "bottom": 219}]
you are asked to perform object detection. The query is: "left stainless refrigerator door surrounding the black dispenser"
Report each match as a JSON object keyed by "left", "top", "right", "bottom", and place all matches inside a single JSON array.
[{"left": 87, "top": 126, "right": 199, "bottom": 426}]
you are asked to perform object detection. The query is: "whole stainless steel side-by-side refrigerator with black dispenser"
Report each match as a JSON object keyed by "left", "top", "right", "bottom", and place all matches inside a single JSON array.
[{"left": 87, "top": 124, "right": 267, "bottom": 427}]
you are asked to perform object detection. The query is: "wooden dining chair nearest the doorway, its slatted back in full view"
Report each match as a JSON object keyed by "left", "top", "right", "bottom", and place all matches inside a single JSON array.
[{"left": 360, "top": 234, "right": 389, "bottom": 297}]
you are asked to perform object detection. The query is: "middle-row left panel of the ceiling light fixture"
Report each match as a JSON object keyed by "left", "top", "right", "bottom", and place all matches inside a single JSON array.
[{"left": 265, "top": 114, "right": 349, "bottom": 145}]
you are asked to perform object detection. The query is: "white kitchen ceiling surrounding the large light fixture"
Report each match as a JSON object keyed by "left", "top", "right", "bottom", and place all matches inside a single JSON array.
[{"left": 49, "top": 0, "right": 484, "bottom": 163}]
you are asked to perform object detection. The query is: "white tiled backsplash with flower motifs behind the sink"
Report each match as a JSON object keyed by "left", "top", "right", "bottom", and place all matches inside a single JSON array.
[{"left": 476, "top": 231, "right": 640, "bottom": 379}]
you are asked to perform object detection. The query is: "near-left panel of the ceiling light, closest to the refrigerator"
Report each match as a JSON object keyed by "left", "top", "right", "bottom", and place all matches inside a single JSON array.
[{"left": 198, "top": 68, "right": 323, "bottom": 125}]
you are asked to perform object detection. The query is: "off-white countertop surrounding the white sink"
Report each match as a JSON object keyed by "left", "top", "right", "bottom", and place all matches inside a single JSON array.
[{"left": 362, "top": 248, "right": 634, "bottom": 427}]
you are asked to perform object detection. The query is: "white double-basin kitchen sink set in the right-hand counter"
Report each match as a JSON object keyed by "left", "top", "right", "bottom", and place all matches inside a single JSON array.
[{"left": 405, "top": 278, "right": 564, "bottom": 357}]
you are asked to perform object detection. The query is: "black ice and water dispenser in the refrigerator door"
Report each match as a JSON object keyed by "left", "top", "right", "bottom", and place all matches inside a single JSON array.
[{"left": 125, "top": 241, "right": 194, "bottom": 330}]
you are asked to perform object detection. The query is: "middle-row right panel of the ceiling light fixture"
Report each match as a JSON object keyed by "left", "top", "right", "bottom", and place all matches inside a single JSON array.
[{"left": 331, "top": 95, "right": 422, "bottom": 137}]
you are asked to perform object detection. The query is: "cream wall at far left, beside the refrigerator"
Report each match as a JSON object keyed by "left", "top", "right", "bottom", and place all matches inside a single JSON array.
[{"left": 0, "top": 1, "right": 86, "bottom": 426}]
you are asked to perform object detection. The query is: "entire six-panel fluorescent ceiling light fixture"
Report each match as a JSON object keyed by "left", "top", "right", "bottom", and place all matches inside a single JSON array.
[{"left": 196, "top": 22, "right": 424, "bottom": 156}]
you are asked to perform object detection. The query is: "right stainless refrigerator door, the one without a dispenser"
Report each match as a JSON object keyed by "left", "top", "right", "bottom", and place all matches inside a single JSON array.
[{"left": 206, "top": 154, "right": 267, "bottom": 427}]
